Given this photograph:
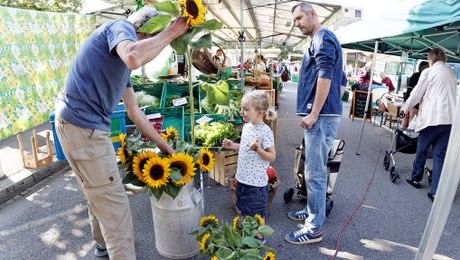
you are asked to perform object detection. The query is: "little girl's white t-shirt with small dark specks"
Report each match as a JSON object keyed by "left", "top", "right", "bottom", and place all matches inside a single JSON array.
[{"left": 235, "top": 123, "right": 275, "bottom": 187}]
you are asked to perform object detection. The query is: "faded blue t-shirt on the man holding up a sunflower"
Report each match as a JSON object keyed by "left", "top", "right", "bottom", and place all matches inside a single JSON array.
[{"left": 56, "top": 20, "right": 138, "bottom": 132}]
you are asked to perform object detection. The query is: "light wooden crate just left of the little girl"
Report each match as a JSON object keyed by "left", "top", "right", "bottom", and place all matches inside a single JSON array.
[{"left": 209, "top": 151, "right": 238, "bottom": 186}]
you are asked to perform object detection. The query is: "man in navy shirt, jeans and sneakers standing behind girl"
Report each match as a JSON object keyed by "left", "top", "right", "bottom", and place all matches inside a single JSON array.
[{"left": 286, "top": 3, "right": 343, "bottom": 244}]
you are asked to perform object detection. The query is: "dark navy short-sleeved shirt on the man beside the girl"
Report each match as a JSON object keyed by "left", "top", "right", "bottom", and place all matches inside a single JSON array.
[{"left": 296, "top": 28, "right": 346, "bottom": 116}]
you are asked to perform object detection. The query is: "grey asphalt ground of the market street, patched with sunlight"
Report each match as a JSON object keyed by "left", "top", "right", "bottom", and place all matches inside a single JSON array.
[{"left": 0, "top": 85, "right": 460, "bottom": 260}]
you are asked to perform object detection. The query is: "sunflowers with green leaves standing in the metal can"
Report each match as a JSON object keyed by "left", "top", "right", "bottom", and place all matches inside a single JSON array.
[{"left": 117, "top": 128, "right": 214, "bottom": 200}]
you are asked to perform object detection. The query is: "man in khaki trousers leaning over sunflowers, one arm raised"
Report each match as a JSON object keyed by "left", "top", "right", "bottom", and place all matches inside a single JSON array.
[{"left": 56, "top": 7, "right": 188, "bottom": 259}]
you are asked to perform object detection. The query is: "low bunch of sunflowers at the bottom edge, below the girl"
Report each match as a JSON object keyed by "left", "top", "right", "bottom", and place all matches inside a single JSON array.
[{"left": 193, "top": 215, "right": 275, "bottom": 260}]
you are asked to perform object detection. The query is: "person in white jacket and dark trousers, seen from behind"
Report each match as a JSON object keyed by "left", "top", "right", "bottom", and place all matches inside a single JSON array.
[{"left": 401, "top": 48, "right": 457, "bottom": 203}]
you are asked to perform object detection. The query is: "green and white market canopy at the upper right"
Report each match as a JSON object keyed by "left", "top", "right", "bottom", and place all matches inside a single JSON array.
[{"left": 336, "top": 0, "right": 460, "bottom": 62}]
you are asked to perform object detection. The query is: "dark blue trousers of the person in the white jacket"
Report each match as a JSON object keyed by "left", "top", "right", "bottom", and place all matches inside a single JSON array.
[{"left": 411, "top": 125, "right": 452, "bottom": 194}]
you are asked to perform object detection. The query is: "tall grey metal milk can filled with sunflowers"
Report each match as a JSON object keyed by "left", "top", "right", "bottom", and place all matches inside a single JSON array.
[{"left": 117, "top": 128, "right": 214, "bottom": 259}]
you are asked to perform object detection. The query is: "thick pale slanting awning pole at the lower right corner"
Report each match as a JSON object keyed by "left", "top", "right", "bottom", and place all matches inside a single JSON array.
[{"left": 415, "top": 96, "right": 460, "bottom": 260}]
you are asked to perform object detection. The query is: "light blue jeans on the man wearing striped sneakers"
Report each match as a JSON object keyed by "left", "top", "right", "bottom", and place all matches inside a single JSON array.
[{"left": 304, "top": 116, "right": 340, "bottom": 229}]
